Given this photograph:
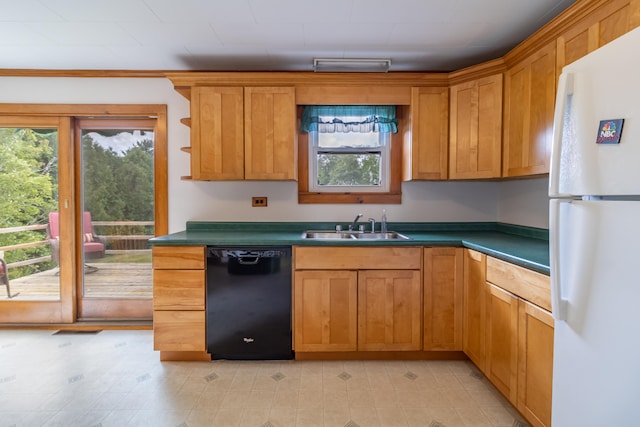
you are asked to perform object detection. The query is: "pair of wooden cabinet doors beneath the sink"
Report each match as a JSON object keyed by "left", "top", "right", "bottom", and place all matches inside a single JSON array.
[{"left": 294, "top": 270, "right": 422, "bottom": 352}]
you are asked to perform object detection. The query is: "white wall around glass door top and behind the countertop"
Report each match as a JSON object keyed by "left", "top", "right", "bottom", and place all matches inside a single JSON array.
[{"left": 0, "top": 77, "right": 547, "bottom": 232}]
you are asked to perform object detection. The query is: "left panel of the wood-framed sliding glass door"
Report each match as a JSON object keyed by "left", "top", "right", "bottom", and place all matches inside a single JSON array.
[{"left": 0, "top": 117, "right": 73, "bottom": 323}]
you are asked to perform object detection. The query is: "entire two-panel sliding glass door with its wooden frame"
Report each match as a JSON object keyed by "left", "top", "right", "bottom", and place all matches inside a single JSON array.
[{"left": 0, "top": 104, "right": 168, "bottom": 324}]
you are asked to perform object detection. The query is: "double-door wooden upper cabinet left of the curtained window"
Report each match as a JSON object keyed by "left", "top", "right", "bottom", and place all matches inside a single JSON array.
[{"left": 191, "top": 86, "right": 297, "bottom": 181}]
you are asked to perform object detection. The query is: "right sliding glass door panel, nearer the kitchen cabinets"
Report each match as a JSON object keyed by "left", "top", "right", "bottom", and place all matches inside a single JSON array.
[{"left": 75, "top": 118, "right": 156, "bottom": 320}]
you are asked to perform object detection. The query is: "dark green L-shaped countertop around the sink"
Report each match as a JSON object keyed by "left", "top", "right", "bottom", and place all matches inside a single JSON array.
[{"left": 149, "top": 221, "right": 549, "bottom": 275}]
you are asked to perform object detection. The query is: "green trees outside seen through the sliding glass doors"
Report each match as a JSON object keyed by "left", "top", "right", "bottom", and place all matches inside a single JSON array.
[{"left": 0, "top": 128, "right": 154, "bottom": 278}]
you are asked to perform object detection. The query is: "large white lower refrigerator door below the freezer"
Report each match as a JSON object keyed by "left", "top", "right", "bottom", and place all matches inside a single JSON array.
[{"left": 552, "top": 200, "right": 640, "bottom": 427}]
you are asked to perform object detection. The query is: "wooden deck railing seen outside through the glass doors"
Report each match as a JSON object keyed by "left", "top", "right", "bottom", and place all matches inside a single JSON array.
[{"left": 0, "top": 221, "right": 154, "bottom": 270}]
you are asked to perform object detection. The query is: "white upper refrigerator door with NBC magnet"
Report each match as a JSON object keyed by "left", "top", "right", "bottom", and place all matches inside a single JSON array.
[{"left": 549, "top": 28, "right": 640, "bottom": 197}]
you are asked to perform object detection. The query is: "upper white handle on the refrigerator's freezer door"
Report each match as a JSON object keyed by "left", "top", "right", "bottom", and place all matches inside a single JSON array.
[{"left": 549, "top": 72, "right": 573, "bottom": 197}]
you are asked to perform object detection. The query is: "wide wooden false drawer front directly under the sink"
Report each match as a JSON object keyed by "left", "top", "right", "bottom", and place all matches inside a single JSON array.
[{"left": 294, "top": 246, "right": 422, "bottom": 270}]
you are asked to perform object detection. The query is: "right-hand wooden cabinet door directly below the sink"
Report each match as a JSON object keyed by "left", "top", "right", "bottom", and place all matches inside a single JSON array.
[{"left": 358, "top": 270, "right": 422, "bottom": 351}]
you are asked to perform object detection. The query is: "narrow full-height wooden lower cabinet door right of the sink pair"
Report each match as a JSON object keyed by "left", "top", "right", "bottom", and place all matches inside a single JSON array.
[{"left": 423, "top": 248, "right": 463, "bottom": 350}]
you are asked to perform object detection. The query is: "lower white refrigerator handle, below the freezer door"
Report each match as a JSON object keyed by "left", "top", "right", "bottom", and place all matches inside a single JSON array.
[{"left": 549, "top": 199, "right": 571, "bottom": 320}]
